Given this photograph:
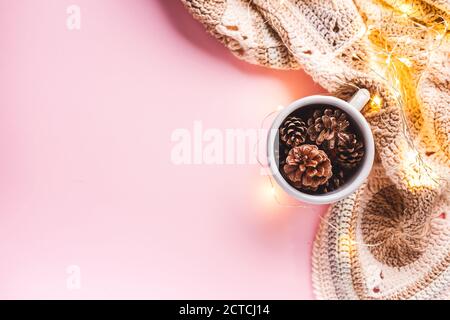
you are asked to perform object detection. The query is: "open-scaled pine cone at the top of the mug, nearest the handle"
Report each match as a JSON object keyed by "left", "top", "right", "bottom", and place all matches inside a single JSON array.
[{"left": 307, "top": 109, "right": 350, "bottom": 150}]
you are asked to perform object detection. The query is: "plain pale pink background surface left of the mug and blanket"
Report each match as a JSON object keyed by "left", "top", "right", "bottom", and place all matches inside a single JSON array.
[{"left": 0, "top": 0, "right": 325, "bottom": 299}]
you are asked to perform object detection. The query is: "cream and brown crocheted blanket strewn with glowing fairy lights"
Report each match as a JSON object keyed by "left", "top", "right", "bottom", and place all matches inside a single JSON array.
[{"left": 182, "top": 0, "right": 450, "bottom": 299}]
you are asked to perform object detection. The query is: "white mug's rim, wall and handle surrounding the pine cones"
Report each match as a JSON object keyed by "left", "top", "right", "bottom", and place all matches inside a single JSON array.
[{"left": 267, "top": 89, "right": 375, "bottom": 204}]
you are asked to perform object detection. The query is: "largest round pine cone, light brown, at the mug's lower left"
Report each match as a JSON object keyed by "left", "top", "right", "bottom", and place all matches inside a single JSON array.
[{"left": 283, "top": 144, "right": 332, "bottom": 191}]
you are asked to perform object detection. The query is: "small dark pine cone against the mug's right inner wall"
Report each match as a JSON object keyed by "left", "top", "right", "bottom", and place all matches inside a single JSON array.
[{"left": 336, "top": 134, "right": 364, "bottom": 169}]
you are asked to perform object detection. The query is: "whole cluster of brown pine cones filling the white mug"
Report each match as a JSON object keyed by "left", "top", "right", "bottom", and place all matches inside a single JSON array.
[{"left": 280, "top": 107, "right": 364, "bottom": 193}]
